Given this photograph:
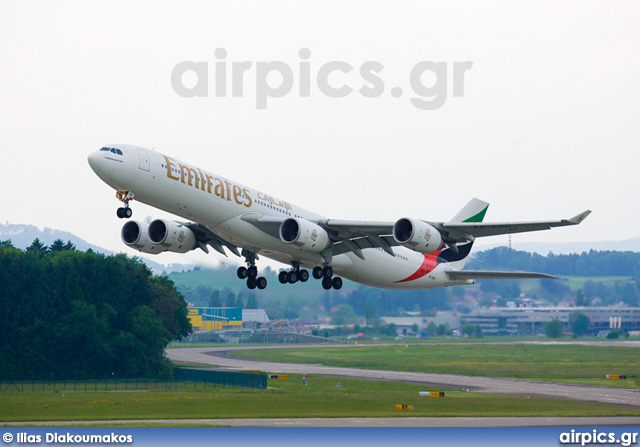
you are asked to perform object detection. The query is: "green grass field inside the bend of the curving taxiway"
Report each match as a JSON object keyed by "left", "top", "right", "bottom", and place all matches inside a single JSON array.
[{"left": 231, "top": 343, "right": 640, "bottom": 388}]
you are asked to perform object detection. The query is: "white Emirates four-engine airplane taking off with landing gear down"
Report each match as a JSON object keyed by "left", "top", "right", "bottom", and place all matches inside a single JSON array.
[{"left": 88, "top": 144, "right": 591, "bottom": 290}]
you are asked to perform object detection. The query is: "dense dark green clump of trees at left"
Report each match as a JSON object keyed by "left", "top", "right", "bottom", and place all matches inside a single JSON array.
[{"left": 0, "top": 239, "right": 191, "bottom": 379}]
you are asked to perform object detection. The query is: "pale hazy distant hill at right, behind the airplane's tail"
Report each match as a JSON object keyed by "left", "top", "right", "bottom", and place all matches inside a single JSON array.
[{"left": 474, "top": 237, "right": 640, "bottom": 256}]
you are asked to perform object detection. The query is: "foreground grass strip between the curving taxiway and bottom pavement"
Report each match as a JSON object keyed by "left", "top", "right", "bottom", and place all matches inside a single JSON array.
[{"left": 0, "top": 375, "right": 640, "bottom": 422}]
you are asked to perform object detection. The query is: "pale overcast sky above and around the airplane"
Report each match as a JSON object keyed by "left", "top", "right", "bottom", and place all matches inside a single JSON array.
[{"left": 0, "top": 0, "right": 640, "bottom": 268}]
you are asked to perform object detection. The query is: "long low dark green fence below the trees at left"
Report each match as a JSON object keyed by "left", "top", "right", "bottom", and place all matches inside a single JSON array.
[{"left": 0, "top": 368, "right": 267, "bottom": 393}]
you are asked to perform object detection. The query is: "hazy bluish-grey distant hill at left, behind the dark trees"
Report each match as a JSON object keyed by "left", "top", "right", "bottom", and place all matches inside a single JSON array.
[{"left": 0, "top": 223, "right": 193, "bottom": 274}]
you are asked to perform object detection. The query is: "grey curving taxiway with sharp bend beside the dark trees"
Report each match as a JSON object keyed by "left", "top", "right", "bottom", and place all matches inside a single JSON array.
[{"left": 167, "top": 342, "right": 640, "bottom": 407}]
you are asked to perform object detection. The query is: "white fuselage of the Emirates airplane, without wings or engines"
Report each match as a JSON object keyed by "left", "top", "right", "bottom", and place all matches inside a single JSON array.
[{"left": 89, "top": 144, "right": 470, "bottom": 289}]
